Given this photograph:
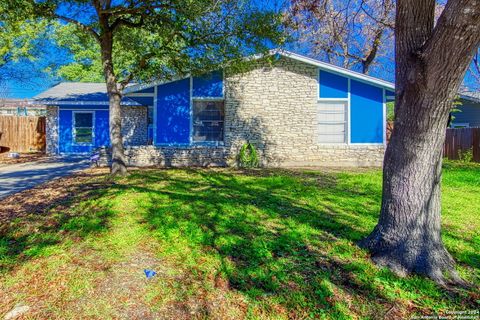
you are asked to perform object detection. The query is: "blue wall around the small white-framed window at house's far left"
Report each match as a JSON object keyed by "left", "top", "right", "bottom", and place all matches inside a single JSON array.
[{"left": 58, "top": 106, "right": 110, "bottom": 153}]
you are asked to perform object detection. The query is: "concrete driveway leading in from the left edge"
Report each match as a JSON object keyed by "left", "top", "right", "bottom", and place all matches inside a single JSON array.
[{"left": 0, "top": 156, "right": 90, "bottom": 199}]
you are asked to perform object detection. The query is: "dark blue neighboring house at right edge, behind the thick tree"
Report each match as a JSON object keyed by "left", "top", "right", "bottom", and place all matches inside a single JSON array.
[{"left": 450, "top": 92, "right": 480, "bottom": 128}]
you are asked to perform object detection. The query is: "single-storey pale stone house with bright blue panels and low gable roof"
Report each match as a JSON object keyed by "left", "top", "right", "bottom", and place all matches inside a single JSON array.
[{"left": 35, "top": 51, "right": 394, "bottom": 166}]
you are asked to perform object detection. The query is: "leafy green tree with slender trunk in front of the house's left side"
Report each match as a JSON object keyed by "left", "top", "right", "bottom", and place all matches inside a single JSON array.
[{"left": 10, "top": 0, "right": 282, "bottom": 174}]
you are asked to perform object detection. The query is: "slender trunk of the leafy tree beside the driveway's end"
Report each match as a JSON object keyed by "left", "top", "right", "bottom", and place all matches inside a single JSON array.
[{"left": 100, "top": 32, "right": 127, "bottom": 175}]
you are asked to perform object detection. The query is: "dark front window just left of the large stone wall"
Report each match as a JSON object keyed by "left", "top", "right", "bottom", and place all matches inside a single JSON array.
[{"left": 192, "top": 100, "right": 225, "bottom": 142}]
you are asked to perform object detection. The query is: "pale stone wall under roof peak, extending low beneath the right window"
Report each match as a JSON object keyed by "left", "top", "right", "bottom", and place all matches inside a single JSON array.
[{"left": 225, "top": 58, "right": 384, "bottom": 166}]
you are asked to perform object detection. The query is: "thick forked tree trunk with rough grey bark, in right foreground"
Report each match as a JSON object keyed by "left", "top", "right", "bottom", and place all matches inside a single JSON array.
[{"left": 360, "top": 0, "right": 480, "bottom": 284}]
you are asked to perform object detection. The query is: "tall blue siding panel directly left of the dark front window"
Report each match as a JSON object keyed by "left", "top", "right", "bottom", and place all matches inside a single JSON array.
[{"left": 156, "top": 79, "right": 190, "bottom": 144}]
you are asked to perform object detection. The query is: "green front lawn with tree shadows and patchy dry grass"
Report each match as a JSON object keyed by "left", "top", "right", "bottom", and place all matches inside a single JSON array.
[{"left": 0, "top": 162, "right": 480, "bottom": 319}]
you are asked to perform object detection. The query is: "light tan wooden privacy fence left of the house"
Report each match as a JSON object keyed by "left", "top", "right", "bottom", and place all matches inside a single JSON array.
[{"left": 0, "top": 116, "right": 45, "bottom": 152}]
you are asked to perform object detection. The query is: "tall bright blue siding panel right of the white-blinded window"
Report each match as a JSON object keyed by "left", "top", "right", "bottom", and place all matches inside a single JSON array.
[{"left": 350, "top": 80, "right": 383, "bottom": 143}]
